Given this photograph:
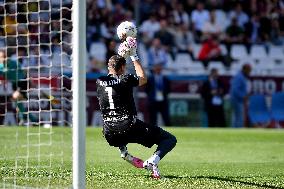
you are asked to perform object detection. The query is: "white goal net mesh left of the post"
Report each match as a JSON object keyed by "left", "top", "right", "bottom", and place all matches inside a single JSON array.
[{"left": 0, "top": 0, "right": 72, "bottom": 188}]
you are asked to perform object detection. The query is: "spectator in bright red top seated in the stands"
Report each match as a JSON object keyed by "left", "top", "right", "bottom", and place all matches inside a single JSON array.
[{"left": 198, "top": 35, "right": 231, "bottom": 67}]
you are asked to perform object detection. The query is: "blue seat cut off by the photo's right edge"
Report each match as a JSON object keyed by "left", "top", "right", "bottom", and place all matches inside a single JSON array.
[{"left": 271, "top": 92, "right": 284, "bottom": 122}]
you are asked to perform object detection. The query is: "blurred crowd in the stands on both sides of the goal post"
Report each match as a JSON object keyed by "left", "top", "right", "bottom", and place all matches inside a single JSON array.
[{"left": 0, "top": 0, "right": 284, "bottom": 73}]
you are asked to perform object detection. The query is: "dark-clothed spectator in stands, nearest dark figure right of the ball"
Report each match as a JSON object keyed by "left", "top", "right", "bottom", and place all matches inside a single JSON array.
[{"left": 154, "top": 20, "right": 176, "bottom": 59}]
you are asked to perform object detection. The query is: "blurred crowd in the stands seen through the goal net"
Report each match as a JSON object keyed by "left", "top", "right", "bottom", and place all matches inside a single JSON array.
[{"left": 0, "top": 0, "right": 72, "bottom": 74}]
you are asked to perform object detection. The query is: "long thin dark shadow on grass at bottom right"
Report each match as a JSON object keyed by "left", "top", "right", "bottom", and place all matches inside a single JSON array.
[{"left": 164, "top": 175, "right": 284, "bottom": 189}]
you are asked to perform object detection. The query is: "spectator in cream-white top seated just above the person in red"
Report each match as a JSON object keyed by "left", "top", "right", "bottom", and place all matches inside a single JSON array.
[{"left": 202, "top": 11, "right": 222, "bottom": 37}]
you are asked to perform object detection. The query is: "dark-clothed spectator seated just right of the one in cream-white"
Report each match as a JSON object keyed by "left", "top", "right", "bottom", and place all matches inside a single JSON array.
[{"left": 224, "top": 18, "right": 244, "bottom": 54}]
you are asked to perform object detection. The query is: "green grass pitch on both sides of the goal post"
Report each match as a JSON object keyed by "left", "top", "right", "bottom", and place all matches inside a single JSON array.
[{"left": 0, "top": 127, "right": 284, "bottom": 189}]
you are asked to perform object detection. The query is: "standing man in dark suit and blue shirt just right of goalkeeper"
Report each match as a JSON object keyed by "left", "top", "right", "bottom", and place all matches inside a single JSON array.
[{"left": 146, "top": 64, "right": 171, "bottom": 126}]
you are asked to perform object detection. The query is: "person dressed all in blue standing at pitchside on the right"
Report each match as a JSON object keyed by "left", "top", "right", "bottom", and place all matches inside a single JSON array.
[{"left": 230, "top": 64, "right": 252, "bottom": 128}]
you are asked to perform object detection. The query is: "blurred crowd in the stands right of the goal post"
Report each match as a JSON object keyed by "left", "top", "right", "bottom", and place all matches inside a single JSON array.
[{"left": 87, "top": 0, "right": 284, "bottom": 71}]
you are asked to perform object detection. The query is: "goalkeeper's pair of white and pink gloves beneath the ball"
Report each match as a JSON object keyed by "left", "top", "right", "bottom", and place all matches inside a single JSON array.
[{"left": 118, "top": 37, "right": 139, "bottom": 61}]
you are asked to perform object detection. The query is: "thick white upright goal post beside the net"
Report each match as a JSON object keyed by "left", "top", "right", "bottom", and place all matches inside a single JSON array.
[{"left": 72, "top": 0, "right": 86, "bottom": 189}]
